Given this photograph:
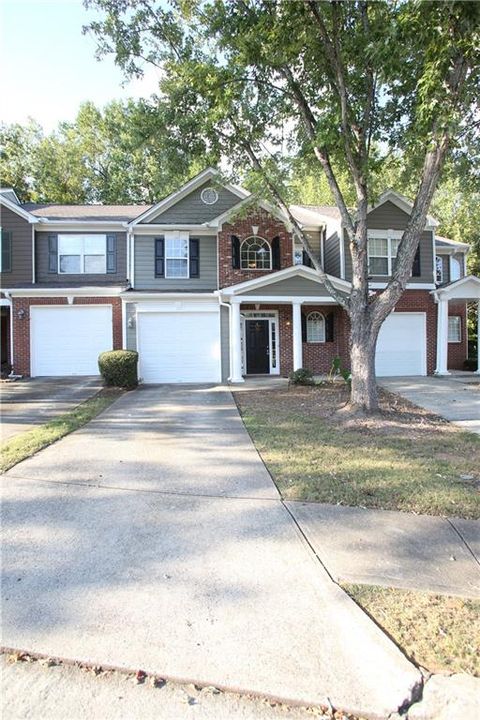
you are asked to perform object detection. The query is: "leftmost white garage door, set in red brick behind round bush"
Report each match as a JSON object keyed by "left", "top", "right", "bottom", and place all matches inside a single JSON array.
[{"left": 30, "top": 305, "right": 113, "bottom": 377}]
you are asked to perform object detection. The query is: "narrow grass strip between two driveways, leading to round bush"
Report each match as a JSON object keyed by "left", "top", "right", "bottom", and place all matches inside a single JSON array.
[{"left": 0, "top": 388, "right": 124, "bottom": 473}]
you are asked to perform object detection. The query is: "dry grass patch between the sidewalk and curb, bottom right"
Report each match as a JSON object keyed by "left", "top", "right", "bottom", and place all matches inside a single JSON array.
[{"left": 343, "top": 585, "right": 480, "bottom": 676}]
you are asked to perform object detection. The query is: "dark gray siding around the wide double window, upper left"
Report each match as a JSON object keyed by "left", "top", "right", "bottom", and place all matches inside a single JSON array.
[{"left": 35, "top": 231, "right": 127, "bottom": 285}]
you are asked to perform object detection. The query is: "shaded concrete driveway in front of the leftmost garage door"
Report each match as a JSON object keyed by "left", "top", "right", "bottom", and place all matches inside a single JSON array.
[{"left": 0, "top": 377, "right": 102, "bottom": 441}]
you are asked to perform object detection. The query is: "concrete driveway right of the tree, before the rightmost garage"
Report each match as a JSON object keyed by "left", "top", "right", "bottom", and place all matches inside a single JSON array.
[{"left": 379, "top": 373, "right": 480, "bottom": 435}]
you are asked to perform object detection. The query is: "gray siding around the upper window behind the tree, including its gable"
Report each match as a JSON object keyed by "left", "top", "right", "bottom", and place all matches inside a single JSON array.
[{"left": 343, "top": 202, "right": 434, "bottom": 284}]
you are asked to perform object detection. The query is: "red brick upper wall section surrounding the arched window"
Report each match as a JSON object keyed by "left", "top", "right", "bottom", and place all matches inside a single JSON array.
[{"left": 218, "top": 208, "right": 293, "bottom": 288}]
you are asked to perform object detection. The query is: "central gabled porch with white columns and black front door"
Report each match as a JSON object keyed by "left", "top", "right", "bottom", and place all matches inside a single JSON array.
[{"left": 219, "top": 266, "right": 349, "bottom": 383}]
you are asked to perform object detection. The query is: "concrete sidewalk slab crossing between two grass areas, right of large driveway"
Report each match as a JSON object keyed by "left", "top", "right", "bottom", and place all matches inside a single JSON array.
[{"left": 286, "top": 502, "right": 480, "bottom": 598}]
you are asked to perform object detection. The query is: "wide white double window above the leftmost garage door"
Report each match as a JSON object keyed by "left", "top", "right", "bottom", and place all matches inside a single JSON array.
[{"left": 58, "top": 235, "right": 107, "bottom": 275}]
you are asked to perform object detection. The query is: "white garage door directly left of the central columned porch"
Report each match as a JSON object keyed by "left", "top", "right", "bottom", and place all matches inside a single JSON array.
[{"left": 137, "top": 311, "right": 221, "bottom": 383}]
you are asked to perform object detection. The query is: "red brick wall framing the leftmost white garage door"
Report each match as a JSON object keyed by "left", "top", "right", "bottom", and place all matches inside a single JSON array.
[{"left": 12, "top": 297, "right": 122, "bottom": 377}]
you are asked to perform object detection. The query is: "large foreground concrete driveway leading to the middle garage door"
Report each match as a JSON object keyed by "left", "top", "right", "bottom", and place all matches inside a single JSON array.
[{"left": 2, "top": 386, "right": 420, "bottom": 717}]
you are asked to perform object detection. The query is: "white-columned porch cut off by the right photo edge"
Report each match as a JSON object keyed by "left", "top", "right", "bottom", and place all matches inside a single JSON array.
[{"left": 432, "top": 275, "right": 480, "bottom": 375}]
